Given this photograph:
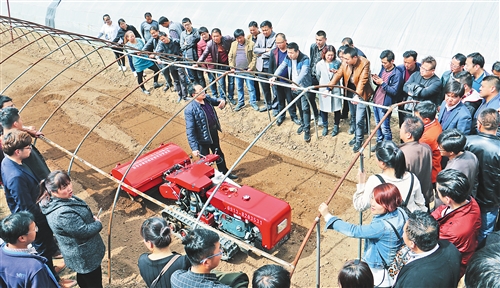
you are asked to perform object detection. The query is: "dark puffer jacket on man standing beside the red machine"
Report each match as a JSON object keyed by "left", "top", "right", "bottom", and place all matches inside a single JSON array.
[{"left": 184, "top": 95, "right": 224, "bottom": 151}]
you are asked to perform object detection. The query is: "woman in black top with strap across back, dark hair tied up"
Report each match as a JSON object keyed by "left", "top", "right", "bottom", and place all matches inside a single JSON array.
[{"left": 138, "top": 217, "right": 191, "bottom": 288}]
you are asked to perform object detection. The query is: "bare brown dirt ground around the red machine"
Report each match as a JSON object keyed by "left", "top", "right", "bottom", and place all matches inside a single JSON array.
[{"left": 0, "top": 29, "right": 399, "bottom": 287}]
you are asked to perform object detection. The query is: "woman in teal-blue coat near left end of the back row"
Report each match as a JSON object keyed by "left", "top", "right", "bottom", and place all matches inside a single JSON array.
[{"left": 125, "top": 31, "right": 161, "bottom": 95}]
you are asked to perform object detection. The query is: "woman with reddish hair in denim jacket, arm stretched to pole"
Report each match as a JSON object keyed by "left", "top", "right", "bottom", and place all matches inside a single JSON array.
[{"left": 318, "top": 183, "right": 408, "bottom": 287}]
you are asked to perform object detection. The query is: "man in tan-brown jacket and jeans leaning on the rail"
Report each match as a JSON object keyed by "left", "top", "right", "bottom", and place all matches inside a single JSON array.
[{"left": 328, "top": 47, "right": 373, "bottom": 152}]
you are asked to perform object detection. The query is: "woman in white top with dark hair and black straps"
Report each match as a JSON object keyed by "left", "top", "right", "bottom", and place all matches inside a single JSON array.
[{"left": 353, "top": 141, "right": 431, "bottom": 212}]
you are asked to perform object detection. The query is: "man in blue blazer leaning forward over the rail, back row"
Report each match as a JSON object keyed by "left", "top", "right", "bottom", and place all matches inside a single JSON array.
[{"left": 270, "top": 42, "right": 318, "bottom": 142}]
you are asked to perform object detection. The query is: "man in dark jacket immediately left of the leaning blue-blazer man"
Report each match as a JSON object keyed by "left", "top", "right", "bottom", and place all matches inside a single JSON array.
[{"left": 269, "top": 33, "right": 302, "bottom": 126}]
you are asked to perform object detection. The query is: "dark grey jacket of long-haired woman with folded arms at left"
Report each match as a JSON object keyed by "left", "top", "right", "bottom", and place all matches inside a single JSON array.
[{"left": 40, "top": 196, "right": 105, "bottom": 274}]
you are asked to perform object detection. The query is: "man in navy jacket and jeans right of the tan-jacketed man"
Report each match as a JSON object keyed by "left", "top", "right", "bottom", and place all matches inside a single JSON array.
[{"left": 372, "top": 50, "right": 403, "bottom": 146}]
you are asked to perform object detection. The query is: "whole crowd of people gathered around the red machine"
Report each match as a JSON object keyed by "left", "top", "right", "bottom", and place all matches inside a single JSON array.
[{"left": 0, "top": 12, "right": 500, "bottom": 288}]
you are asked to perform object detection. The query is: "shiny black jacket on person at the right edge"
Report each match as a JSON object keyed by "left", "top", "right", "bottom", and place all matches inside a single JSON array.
[{"left": 465, "top": 132, "right": 500, "bottom": 208}]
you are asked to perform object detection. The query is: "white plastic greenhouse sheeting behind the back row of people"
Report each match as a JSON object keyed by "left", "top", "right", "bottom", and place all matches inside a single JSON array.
[{"left": 0, "top": 0, "right": 500, "bottom": 76}]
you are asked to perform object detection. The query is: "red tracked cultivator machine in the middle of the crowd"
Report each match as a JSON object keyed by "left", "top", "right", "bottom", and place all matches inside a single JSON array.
[{"left": 112, "top": 143, "right": 291, "bottom": 258}]
